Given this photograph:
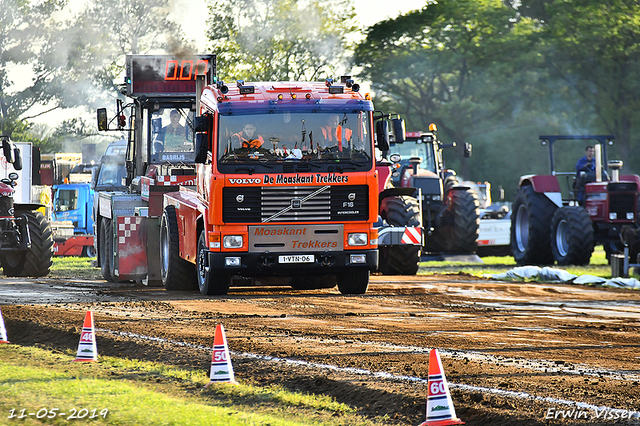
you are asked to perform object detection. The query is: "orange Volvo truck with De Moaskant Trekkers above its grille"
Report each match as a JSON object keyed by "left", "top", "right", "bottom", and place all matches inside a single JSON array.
[{"left": 160, "top": 77, "right": 410, "bottom": 294}]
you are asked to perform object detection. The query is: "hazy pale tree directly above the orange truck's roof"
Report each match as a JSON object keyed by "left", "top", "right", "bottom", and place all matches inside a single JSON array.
[{"left": 207, "top": 0, "right": 355, "bottom": 81}]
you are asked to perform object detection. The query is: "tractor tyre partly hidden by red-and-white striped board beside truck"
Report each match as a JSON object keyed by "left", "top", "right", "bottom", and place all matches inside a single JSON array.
[{"left": 378, "top": 195, "right": 422, "bottom": 275}]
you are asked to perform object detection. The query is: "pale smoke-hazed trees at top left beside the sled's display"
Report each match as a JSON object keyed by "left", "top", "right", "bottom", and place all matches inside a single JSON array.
[{"left": 0, "top": 0, "right": 189, "bottom": 146}]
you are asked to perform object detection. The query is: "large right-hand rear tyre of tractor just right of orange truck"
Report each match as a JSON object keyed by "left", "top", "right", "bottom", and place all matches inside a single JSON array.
[{"left": 433, "top": 189, "right": 480, "bottom": 253}]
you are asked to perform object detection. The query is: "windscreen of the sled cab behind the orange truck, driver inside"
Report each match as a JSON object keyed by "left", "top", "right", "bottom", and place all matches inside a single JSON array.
[{"left": 151, "top": 108, "right": 194, "bottom": 160}]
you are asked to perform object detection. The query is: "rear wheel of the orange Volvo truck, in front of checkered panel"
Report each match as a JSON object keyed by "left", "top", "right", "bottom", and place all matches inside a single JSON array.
[{"left": 160, "top": 206, "right": 198, "bottom": 291}]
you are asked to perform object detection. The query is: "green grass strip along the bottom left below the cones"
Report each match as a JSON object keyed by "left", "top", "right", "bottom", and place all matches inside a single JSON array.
[{"left": 0, "top": 345, "right": 377, "bottom": 426}]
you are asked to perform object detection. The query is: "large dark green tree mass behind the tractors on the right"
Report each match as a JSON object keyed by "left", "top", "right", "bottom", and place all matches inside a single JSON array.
[{"left": 355, "top": 0, "right": 640, "bottom": 193}]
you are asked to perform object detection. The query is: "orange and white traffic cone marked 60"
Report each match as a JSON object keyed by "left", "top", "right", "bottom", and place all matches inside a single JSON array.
[{"left": 420, "top": 349, "right": 464, "bottom": 426}]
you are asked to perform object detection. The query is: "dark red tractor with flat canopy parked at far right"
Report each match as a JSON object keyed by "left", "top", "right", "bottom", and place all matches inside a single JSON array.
[{"left": 511, "top": 135, "right": 640, "bottom": 265}]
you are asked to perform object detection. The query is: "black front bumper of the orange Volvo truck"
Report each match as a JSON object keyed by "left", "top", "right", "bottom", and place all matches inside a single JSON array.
[{"left": 209, "top": 249, "right": 378, "bottom": 276}]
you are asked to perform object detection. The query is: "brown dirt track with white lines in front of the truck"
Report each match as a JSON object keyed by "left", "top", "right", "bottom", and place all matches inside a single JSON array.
[{"left": 0, "top": 275, "right": 640, "bottom": 425}]
